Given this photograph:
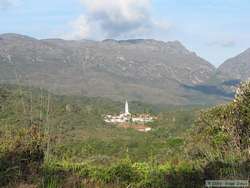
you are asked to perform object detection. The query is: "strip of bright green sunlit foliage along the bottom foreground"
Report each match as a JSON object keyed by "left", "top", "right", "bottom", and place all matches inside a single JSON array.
[{"left": 40, "top": 159, "right": 204, "bottom": 188}]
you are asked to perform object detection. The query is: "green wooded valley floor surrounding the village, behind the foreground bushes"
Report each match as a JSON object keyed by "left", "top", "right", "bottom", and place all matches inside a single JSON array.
[{"left": 0, "top": 85, "right": 203, "bottom": 162}]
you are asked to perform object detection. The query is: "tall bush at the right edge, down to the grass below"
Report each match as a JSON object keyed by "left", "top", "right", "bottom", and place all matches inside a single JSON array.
[{"left": 193, "top": 82, "right": 250, "bottom": 160}]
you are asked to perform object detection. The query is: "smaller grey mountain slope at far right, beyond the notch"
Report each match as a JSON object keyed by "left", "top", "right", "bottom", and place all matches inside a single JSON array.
[{"left": 217, "top": 48, "right": 250, "bottom": 80}]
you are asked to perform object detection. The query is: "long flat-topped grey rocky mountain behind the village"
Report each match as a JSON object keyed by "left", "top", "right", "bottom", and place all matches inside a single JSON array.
[{"left": 0, "top": 34, "right": 228, "bottom": 104}]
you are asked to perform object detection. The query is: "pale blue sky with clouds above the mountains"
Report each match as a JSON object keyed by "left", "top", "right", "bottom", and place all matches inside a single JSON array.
[{"left": 0, "top": 0, "right": 250, "bottom": 66}]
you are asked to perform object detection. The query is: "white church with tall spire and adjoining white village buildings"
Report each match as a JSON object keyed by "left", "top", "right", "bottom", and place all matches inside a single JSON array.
[{"left": 104, "top": 100, "right": 155, "bottom": 124}]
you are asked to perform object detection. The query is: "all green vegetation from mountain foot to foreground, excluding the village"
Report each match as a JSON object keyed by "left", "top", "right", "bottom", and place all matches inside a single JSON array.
[{"left": 0, "top": 83, "right": 250, "bottom": 188}]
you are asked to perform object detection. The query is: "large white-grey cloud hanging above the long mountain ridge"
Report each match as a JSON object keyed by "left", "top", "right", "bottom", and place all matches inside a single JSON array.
[{"left": 63, "top": 0, "right": 169, "bottom": 39}]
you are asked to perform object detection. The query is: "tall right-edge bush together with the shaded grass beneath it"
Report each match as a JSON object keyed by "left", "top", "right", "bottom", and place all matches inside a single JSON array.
[{"left": 188, "top": 82, "right": 250, "bottom": 179}]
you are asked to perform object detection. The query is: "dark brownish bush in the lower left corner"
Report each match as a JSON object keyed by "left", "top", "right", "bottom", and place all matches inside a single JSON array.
[{"left": 0, "top": 127, "right": 44, "bottom": 186}]
